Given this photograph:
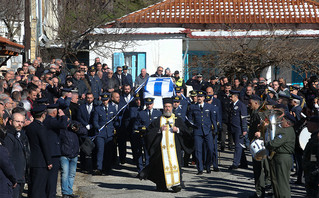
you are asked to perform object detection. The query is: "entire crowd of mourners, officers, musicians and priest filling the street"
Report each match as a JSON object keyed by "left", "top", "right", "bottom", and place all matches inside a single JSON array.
[{"left": 0, "top": 57, "right": 319, "bottom": 198}]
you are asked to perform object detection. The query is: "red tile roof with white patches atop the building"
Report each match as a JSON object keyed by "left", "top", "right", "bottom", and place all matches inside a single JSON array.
[{"left": 117, "top": 0, "right": 319, "bottom": 24}]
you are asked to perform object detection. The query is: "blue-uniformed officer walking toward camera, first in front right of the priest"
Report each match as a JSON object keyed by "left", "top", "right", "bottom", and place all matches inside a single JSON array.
[{"left": 187, "top": 91, "right": 218, "bottom": 174}]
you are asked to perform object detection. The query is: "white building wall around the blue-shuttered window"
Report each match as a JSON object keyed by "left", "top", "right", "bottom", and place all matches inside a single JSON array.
[{"left": 90, "top": 38, "right": 183, "bottom": 75}]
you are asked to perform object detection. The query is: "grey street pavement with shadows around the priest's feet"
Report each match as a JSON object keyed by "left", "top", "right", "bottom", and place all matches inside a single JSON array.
[{"left": 66, "top": 149, "right": 306, "bottom": 198}]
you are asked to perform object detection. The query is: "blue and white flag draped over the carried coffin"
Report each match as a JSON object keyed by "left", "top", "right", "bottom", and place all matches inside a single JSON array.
[{"left": 144, "top": 77, "right": 175, "bottom": 109}]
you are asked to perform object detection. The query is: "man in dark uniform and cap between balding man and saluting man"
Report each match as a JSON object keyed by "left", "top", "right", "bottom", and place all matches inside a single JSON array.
[{"left": 26, "top": 105, "right": 52, "bottom": 198}]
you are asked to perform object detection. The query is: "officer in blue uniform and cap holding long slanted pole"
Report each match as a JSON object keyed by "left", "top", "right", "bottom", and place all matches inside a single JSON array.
[{"left": 93, "top": 93, "right": 116, "bottom": 175}]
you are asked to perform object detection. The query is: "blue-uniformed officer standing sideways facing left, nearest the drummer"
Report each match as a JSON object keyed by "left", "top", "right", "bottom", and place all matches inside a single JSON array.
[{"left": 229, "top": 90, "right": 248, "bottom": 170}]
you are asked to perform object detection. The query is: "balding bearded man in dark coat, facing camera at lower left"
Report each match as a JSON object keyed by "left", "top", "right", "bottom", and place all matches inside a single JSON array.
[{"left": 4, "top": 113, "right": 28, "bottom": 198}]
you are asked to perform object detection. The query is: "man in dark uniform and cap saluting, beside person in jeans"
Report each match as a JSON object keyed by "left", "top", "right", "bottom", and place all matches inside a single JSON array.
[{"left": 43, "top": 104, "right": 68, "bottom": 198}]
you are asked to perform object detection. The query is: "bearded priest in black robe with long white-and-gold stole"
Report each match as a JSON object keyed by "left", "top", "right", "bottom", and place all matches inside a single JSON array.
[{"left": 139, "top": 98, "right": 192, "bottom": 192}]
